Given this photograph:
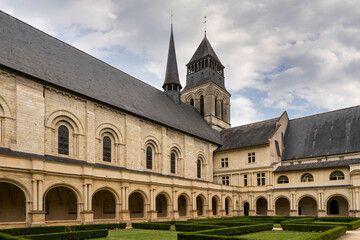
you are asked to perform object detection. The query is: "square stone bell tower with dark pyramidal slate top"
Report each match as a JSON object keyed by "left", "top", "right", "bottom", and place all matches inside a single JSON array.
[{"left": 181, "top": 32, "right": 231, "bottom": 131}]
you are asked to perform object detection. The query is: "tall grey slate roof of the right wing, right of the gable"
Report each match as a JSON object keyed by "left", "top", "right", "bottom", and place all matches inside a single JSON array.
[{"left": 282, "top": 106, "right": 360, "bottom": 160}]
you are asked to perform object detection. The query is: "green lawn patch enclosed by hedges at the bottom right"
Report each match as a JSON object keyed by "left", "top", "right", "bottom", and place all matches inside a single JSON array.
[{"left": 239, "top": 230, "right": 318, "bottom": 240}]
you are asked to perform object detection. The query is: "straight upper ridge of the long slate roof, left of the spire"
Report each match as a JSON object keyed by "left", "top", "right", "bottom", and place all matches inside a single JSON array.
[{"left": 0, "top": 10, "right": 162, "bottom": 92}]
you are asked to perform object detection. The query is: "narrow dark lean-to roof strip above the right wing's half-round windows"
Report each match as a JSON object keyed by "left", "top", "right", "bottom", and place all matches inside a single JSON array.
[{"left": 274, "top": 158, "right": 360, "bottom": 172}]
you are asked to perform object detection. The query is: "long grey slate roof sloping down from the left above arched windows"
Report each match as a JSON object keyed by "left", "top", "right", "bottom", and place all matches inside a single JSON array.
[{"left": 0, "top": 11, "right": 221, "bottom": 143}]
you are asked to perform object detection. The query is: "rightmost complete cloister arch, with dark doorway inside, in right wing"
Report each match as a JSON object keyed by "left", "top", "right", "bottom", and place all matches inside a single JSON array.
[{"left": 325, "top": 194, "right": 349, "bottom": 217}]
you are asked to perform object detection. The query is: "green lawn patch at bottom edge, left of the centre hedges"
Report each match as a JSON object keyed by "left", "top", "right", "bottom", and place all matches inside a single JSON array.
[{"left": 90, "top": 228, "right": 177, "bottom": 240}]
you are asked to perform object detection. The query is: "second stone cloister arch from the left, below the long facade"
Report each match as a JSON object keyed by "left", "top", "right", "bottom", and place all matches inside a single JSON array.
[{"left": 43, "top": 184, "right": 81, "bottom": 221}]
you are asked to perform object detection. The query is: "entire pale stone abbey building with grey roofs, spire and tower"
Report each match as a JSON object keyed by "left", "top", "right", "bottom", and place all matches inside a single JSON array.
[{"left": 0, "top": 12, "right": 360, "bottom": 228}]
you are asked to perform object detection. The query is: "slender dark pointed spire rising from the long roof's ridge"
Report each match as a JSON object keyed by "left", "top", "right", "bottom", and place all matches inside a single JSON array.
[{"left": 163, "top": 23, "right": 182, "bottom": 92}]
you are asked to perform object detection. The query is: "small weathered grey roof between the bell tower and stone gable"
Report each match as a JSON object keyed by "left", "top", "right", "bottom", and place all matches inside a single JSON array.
[{"left": 216, "top": 118, "right": 279, "bottom": 152}]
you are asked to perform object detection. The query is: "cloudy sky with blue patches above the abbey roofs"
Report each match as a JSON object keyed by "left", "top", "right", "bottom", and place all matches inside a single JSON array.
[{"left": 0, "top": 0, "right": 360, "bottom": 126}]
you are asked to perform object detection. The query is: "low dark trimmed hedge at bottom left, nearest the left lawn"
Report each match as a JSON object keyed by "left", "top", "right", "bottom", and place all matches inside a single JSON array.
[{"left": 24, "top": 229, "right": 109, "bottom": 240}]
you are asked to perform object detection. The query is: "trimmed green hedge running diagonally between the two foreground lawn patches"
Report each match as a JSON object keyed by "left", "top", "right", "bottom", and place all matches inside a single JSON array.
[{"left": 178, "top": 223, "right": 273, "bottom": 240}]
